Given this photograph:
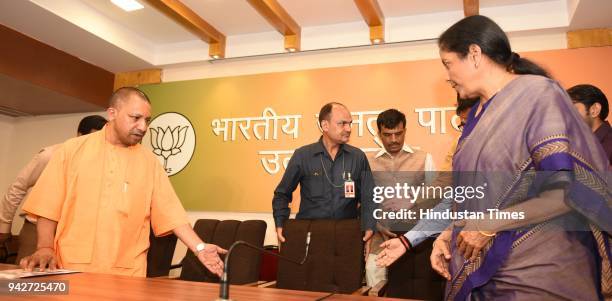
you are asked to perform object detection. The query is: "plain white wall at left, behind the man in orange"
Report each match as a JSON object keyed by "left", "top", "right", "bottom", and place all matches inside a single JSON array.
[{"left": 0, "top": 112, "right": 106, "bottom": 234}]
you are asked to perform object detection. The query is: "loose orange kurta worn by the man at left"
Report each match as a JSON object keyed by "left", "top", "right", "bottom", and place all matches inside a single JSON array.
[{"left": 23, "top": 127, "right": 188, "bottom": 277}]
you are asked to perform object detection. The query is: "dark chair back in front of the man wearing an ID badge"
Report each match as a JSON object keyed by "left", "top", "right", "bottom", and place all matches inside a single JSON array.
[{"left": 276, "top": 219, "right": 363, "bottom": 293}]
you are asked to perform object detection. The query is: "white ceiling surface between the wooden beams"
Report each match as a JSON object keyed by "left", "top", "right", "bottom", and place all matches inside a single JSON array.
[{"left": 0, "top": 0, "right": 612, "bottom": 72}]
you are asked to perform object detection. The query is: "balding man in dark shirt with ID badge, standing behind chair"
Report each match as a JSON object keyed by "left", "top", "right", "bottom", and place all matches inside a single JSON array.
[{"left": 272, "top": 102, "right": 374, "bottom": 243}]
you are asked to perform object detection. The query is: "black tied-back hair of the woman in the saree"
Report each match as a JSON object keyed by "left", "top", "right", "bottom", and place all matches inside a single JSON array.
[{"left": 438, "top": 15, "right": 550, "bottom": 77}]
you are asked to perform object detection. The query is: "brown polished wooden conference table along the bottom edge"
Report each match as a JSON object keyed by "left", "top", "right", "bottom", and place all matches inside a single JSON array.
[{"left": 0, "top": 264, "right": 414, "bottom": 301}]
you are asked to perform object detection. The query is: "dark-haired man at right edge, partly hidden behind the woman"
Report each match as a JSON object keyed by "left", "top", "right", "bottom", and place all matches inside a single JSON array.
[{"left": 567, "top": 85, "right": 612, "bottom": 164}]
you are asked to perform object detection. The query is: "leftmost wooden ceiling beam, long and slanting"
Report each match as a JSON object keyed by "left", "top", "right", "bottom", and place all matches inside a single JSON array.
[{"left": 147, "top": 0, "right": 225, "bottom": 59}]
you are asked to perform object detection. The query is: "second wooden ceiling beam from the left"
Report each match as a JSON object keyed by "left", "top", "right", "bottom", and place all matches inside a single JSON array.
[{"left": 248, "top": 0, "right": 302, "bottom": 51}]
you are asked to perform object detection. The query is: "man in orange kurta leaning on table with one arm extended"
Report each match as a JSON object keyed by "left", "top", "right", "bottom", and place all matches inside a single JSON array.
[{"left": 20, "top": 88, "right": 225, "bottom": 277}]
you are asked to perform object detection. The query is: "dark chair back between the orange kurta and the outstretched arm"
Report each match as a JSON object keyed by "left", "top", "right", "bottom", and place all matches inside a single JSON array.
[{"left": 147, "top": 230, "right": 176, "bottom": 277}]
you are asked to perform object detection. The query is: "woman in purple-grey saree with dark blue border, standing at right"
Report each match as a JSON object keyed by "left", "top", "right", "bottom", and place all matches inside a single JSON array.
[{"left": 378, "top": 16, "right": 612, "bottom": 300}]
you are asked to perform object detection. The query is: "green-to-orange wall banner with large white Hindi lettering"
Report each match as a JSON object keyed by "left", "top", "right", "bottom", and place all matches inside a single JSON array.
[{"left": 142, "top": 47, "right": 612, "bottom": 212}]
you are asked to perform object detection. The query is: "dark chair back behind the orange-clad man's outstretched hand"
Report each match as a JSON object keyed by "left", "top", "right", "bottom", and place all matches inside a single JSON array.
[{"left": 179, "top": 219, "right": 266, "bottom": 284}]
